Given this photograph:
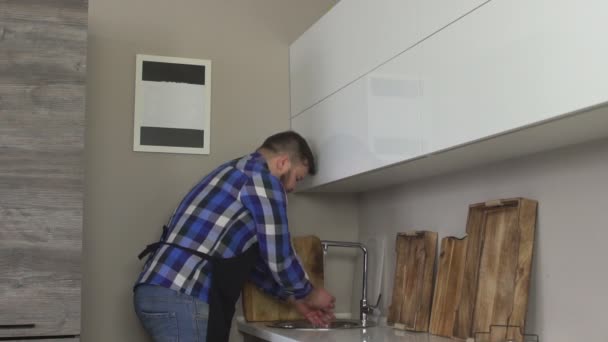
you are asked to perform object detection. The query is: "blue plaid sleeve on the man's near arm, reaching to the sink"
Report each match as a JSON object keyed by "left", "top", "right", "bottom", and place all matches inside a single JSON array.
[{"left": 239, "top": 172, "right": 312, "bottom": 299}]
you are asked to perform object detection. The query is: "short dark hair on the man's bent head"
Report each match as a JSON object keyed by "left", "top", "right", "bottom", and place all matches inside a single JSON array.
[{"left": 260, "top": 131, "right": 317, "bottom": 175}]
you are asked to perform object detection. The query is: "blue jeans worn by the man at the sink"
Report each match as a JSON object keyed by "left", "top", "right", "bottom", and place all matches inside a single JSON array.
[{"left": 133, "top": 285, "right": 209, "bottom": 342}]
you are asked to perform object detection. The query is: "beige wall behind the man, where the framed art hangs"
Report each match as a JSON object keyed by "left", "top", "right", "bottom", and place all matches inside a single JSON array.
[{"left": 82, "top": 0, "right": 357, "bottom": 342}]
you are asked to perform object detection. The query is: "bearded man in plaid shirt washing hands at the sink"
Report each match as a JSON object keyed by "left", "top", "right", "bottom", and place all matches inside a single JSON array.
[{"left": 134, "top": 131, "right": 335, "bottom": 342}]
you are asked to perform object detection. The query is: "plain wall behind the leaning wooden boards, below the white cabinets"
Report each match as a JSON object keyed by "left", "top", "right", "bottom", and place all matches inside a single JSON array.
[{"left": 359, "top": 140, "right": 608, "bottom": 342}]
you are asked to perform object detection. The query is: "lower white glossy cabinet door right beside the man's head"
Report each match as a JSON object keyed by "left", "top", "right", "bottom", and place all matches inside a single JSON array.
[{"left": 292, "top": 44, "right": 427, "bottom": 188}]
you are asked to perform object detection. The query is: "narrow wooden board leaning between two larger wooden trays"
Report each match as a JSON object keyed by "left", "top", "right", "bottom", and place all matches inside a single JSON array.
[{"left": 429, "top": 236, "right": 468, "bottom": 337}]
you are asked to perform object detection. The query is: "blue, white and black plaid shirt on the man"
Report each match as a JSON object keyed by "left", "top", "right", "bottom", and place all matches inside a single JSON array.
[{"left": 136, "top": 152, "right": 312, "bottom": 302}]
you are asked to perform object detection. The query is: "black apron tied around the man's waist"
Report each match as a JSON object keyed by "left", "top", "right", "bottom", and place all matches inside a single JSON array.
[{"left": 138, "top": 227, "right": 259, "bottom": 342}]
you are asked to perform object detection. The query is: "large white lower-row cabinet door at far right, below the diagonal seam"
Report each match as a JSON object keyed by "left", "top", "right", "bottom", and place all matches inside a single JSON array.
[{"left": 421, "top": 0, "right": 608, "bottom": 151}]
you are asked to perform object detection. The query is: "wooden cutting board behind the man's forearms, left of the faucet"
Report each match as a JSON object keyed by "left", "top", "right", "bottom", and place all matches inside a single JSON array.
[{"left": 242, "top": 235, "right": 324, "bottom": 322}]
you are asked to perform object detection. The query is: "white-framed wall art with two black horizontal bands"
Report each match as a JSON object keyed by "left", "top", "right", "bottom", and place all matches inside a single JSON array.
[{"left": 133, "top": 55, "right": 211, "bottom": 154}]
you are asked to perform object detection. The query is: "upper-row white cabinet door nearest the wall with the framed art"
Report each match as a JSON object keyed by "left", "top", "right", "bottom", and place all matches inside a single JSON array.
[{"left": 289, "top": 0, "right": 420, "bottom": 116}]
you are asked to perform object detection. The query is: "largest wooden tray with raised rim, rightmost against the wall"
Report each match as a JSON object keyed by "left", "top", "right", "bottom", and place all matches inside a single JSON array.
[{"left": 453, "top": 198, "right": 537, "bottom": 339}]
